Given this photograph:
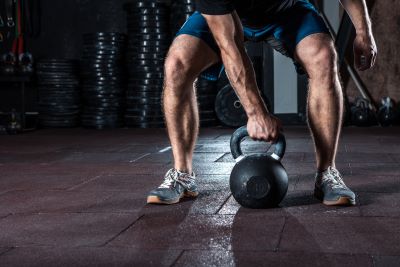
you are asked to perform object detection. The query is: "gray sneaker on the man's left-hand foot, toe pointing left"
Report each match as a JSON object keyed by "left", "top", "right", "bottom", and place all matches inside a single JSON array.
[{"left": 147, "top": 169, "right": 199, "bottom": 204}]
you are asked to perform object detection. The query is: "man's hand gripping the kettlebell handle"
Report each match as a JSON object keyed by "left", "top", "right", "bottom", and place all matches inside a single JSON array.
[{"left": 247, "top": 114, "right": 282, "bottom": 143}]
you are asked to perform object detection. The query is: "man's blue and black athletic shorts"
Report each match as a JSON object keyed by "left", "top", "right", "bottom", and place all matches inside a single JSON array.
[{"left": 176, "top": 0, "right": 329, "bottom": 80}]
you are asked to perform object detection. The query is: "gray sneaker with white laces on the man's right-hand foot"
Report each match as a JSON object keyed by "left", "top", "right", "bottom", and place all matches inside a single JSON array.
[{"left": 314, "top": 167, "right": 356, "bottom": 206}]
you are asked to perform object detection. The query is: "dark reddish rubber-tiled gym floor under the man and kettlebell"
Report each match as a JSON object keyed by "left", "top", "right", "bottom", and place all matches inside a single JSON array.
[{"left": 0, "top": 127, "right": 400, "bottom": 267}]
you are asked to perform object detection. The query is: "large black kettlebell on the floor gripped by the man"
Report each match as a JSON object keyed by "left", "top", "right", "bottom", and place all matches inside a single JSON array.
[{"left": 230, "top": 126, "right": 288, "bottom": 209}]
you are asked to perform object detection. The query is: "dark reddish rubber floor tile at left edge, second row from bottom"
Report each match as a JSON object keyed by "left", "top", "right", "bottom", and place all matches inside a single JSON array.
[{"left": 0, "top": 213, "right": 139, "bottom": 247}]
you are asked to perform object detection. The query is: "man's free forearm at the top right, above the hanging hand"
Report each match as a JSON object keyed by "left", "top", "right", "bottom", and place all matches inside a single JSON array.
[{"left": 340, "top": 0, "right": 372, "bottom": 34}]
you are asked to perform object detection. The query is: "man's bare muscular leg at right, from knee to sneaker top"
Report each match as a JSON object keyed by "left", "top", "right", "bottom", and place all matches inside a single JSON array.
[{"left": 295, "top": 33, "right": 343, "bottom": 172}]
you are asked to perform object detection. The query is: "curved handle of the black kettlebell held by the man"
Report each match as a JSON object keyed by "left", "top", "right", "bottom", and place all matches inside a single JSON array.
[{"left": 231, "top": 126, "right": 286, "bottom": 161}]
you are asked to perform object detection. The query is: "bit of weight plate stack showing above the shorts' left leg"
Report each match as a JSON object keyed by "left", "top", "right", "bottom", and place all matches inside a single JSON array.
[{"left": 171, "top": 0, "right": 195, "bottom": 34}]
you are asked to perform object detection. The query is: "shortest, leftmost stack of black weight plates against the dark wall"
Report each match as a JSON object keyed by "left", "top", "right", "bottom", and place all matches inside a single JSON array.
[{"left": 36, "top": 59, "right": 80, "bottom": 128}]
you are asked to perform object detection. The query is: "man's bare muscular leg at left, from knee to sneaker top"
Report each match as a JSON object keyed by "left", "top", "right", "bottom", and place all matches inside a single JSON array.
[{"left": 163, "top": 34, "right": 219, "bottom": 173}]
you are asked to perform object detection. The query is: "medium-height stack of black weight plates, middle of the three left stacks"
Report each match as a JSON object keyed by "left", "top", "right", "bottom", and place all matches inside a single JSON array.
[{"left": 80, "top": 32, "right": 126, "bottom": 129}]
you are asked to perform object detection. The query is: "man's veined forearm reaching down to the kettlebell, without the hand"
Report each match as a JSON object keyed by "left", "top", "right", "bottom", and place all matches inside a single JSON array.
[{"left": 205, "top": 13, "right": 268, "bottom": 116}]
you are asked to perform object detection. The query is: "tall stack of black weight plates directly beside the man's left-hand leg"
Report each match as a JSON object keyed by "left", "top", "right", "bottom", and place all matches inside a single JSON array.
[{"left": 125, "top": 0, "right": 171, "bottom": 128}]
